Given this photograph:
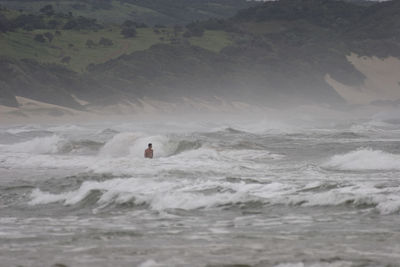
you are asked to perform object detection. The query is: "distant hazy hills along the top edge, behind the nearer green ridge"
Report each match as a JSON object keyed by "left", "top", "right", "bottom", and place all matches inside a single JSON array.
[{"left": 0, "top": 0, "right": 254, "bottom": 25}]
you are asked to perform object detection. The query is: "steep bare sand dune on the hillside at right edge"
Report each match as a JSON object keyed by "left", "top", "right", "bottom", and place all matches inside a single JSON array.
[{"left": 325, "top": 54, "right": 400, "bottom": 104}]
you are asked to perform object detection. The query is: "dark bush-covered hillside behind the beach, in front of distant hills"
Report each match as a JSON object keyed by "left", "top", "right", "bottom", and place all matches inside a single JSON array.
[{"left": 0, "top": 0, "right": 400, "bottom": 109}]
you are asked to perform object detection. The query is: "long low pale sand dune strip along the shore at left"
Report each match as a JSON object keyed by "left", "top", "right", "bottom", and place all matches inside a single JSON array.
[{"left": 0, "top": 96, "right": 262, "bottom": 124}]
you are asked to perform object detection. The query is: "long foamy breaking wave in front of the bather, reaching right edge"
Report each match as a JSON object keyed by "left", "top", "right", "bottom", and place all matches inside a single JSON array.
[{"left": 29, "top": 178, "right": 400, "bottom": 214}]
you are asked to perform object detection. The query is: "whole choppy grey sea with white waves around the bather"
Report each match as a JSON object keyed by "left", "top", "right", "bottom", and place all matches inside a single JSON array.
[{"left": 0, "top": 121, "right": 400, "bottom": 267}]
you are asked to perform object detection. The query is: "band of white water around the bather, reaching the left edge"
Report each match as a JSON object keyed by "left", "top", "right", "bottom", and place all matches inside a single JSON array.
[{"left": 0, "top": 132, "right": 283, "bottom": 176}]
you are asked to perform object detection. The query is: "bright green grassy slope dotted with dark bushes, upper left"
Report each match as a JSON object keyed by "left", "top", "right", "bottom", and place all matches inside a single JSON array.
[{"left": 0, "top": 3, "right": 231, "bottom": 72}]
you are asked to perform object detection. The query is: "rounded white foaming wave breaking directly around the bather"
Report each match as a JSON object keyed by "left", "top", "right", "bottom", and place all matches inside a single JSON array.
[{"left": 88, "top": 132, "right": 283, "bottom": 177}]
